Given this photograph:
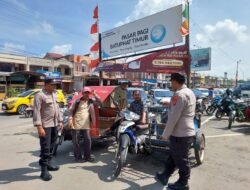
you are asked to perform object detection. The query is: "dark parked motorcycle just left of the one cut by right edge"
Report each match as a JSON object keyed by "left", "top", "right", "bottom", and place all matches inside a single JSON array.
[{"left": 215, "top": 96, "right": 235, "bottom": 119}]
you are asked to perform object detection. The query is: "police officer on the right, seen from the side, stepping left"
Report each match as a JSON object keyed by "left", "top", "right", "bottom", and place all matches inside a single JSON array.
[{"left": 156, "top": 73, "right": 196, "bottom": 190}]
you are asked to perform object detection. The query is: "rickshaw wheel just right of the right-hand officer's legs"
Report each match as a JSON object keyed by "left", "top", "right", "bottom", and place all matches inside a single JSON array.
[{"left": 194, "top": 133, "right": 206, "bottom": 165}]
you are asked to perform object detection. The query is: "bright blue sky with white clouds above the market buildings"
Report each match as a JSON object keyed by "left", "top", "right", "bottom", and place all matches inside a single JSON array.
[{"left": 0, "top": 0, "right": 250, "bottom": 79}]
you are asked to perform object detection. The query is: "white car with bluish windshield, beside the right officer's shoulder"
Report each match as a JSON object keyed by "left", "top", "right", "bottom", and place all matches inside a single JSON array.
[{"left": 149, "top": 89, "right": 173, "bottom": 103}]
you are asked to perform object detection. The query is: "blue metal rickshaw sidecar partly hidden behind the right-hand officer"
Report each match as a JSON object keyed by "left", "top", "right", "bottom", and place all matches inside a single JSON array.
[{"left": 146, "top": 106, "right": 205, "bottom": 165}]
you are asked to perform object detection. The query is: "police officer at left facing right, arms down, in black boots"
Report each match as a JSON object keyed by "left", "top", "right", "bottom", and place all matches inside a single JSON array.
[{"left": 33, "top": 79, "right": 62, "bottom": 181}]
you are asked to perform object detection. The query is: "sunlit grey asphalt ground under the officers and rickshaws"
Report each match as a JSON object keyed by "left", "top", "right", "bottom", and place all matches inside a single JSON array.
[{"left": 0, "top": 112, "right": 250, "bottom": 190}]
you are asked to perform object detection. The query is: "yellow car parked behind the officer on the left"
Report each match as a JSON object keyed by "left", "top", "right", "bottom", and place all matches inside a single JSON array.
[{"left": 2, "top": 89, "right": 66, "bottom": 115}]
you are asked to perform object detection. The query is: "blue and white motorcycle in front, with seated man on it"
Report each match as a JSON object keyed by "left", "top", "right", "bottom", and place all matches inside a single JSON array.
[{"left": 114, "top": 110, "right": 152, "bottom": 177}]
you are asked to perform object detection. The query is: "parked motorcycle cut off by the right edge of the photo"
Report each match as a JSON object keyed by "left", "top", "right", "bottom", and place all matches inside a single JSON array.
[{"left": 228, "top": 100, "right": 250, "bottom": 129}]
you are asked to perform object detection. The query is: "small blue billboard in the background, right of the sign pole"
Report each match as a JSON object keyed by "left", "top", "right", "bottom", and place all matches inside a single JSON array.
[{"left": 190, "top": 48, "right": 211, "bottom": 71}]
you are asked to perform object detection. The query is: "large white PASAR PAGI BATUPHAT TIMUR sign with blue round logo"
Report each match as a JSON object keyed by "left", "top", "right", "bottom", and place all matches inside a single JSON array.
[{"left": 101, "top": 5, "right": 183, "bottom": 60}]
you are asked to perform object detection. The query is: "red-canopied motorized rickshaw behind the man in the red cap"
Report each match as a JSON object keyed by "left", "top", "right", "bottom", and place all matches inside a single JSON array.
[{"left": 53, "top": 86, "right": 119, "bottom": 155}]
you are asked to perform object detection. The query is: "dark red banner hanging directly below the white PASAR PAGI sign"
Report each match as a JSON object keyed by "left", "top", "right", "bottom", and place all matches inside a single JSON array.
[{"left": 95, "top": 46, "right": 190, "bottom": 73}]
